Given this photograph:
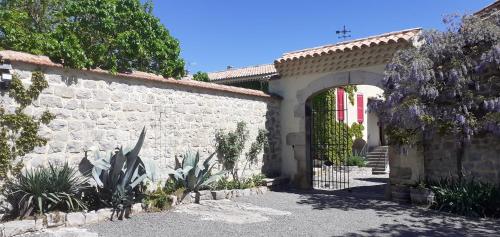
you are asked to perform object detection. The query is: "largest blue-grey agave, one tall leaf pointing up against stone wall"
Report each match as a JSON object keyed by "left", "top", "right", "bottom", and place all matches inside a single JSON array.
[{"left": 90, "top": 128, "right": 148, "bottom": 218}]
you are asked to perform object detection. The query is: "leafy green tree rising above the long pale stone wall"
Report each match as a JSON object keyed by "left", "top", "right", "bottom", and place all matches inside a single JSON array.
[{"left": 0, "top": 0, "right": 185, "bottom": 78}]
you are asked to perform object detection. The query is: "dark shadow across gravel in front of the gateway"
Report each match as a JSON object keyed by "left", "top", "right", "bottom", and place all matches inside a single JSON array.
[{"left": 280, "top": 184, "right": 500, "bottom": 236}]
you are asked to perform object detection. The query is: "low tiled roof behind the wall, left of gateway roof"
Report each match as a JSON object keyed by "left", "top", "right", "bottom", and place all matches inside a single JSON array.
[{"left": 208, "top": 64, "right": 276, "bottom": 81}]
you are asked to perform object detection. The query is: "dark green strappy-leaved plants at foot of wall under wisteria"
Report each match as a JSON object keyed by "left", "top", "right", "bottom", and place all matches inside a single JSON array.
[{"left": 430, "top": 178, "right": 500, "bottom": 217}]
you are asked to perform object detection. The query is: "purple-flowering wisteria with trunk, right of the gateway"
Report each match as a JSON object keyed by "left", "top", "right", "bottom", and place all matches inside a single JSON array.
[{"left": 370, "top": 13, "right": 500, "bottom": 176}]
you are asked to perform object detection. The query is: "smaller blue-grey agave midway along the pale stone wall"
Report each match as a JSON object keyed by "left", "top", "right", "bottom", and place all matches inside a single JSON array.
[{"left": 168, "top": 152, "right": 226, "bottom": 202}]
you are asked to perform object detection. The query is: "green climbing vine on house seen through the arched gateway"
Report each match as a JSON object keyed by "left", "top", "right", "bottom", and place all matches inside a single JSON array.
[{"left": 312, "top": 85, "right": 364, "bottom": 163}]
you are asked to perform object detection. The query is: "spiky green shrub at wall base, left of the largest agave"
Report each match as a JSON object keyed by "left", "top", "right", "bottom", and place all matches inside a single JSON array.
[{"left": 4, "top": 164, "right": 87, "bottom": 217}]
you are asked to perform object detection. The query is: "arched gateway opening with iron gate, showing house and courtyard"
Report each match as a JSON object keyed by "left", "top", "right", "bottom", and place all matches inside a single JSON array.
[{"left": 305, "top": 84, "right": 386, "bottom": 190}]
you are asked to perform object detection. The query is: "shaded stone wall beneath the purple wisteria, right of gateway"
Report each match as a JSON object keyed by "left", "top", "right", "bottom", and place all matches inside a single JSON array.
[{"left": 389, "top": 136, "right": 500, "bottom": 185}]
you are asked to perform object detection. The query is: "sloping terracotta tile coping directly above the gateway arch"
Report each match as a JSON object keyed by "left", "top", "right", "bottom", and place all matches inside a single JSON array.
[{"left": 275, "top": 28, "right": 421, "bottom": 63}]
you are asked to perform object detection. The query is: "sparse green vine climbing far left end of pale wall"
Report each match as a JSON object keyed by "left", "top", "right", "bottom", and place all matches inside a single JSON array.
[{"left": 0, "top": 71, "right": 54, "bottom": 177}]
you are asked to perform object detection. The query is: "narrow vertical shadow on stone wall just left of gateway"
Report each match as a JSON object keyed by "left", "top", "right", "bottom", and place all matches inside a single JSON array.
[{"left": 261, "top": 101, "right": 281, "bottom": 178}]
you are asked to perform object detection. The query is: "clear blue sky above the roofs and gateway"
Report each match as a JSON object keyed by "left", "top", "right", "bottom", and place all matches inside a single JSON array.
[{"left": 153, "top": 0, "right": 495, "bottom": 73}]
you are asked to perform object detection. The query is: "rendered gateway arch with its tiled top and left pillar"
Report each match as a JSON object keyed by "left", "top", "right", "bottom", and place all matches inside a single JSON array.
[{"left": 269, "top": 29, "right": 420, "bottom": 189}]
